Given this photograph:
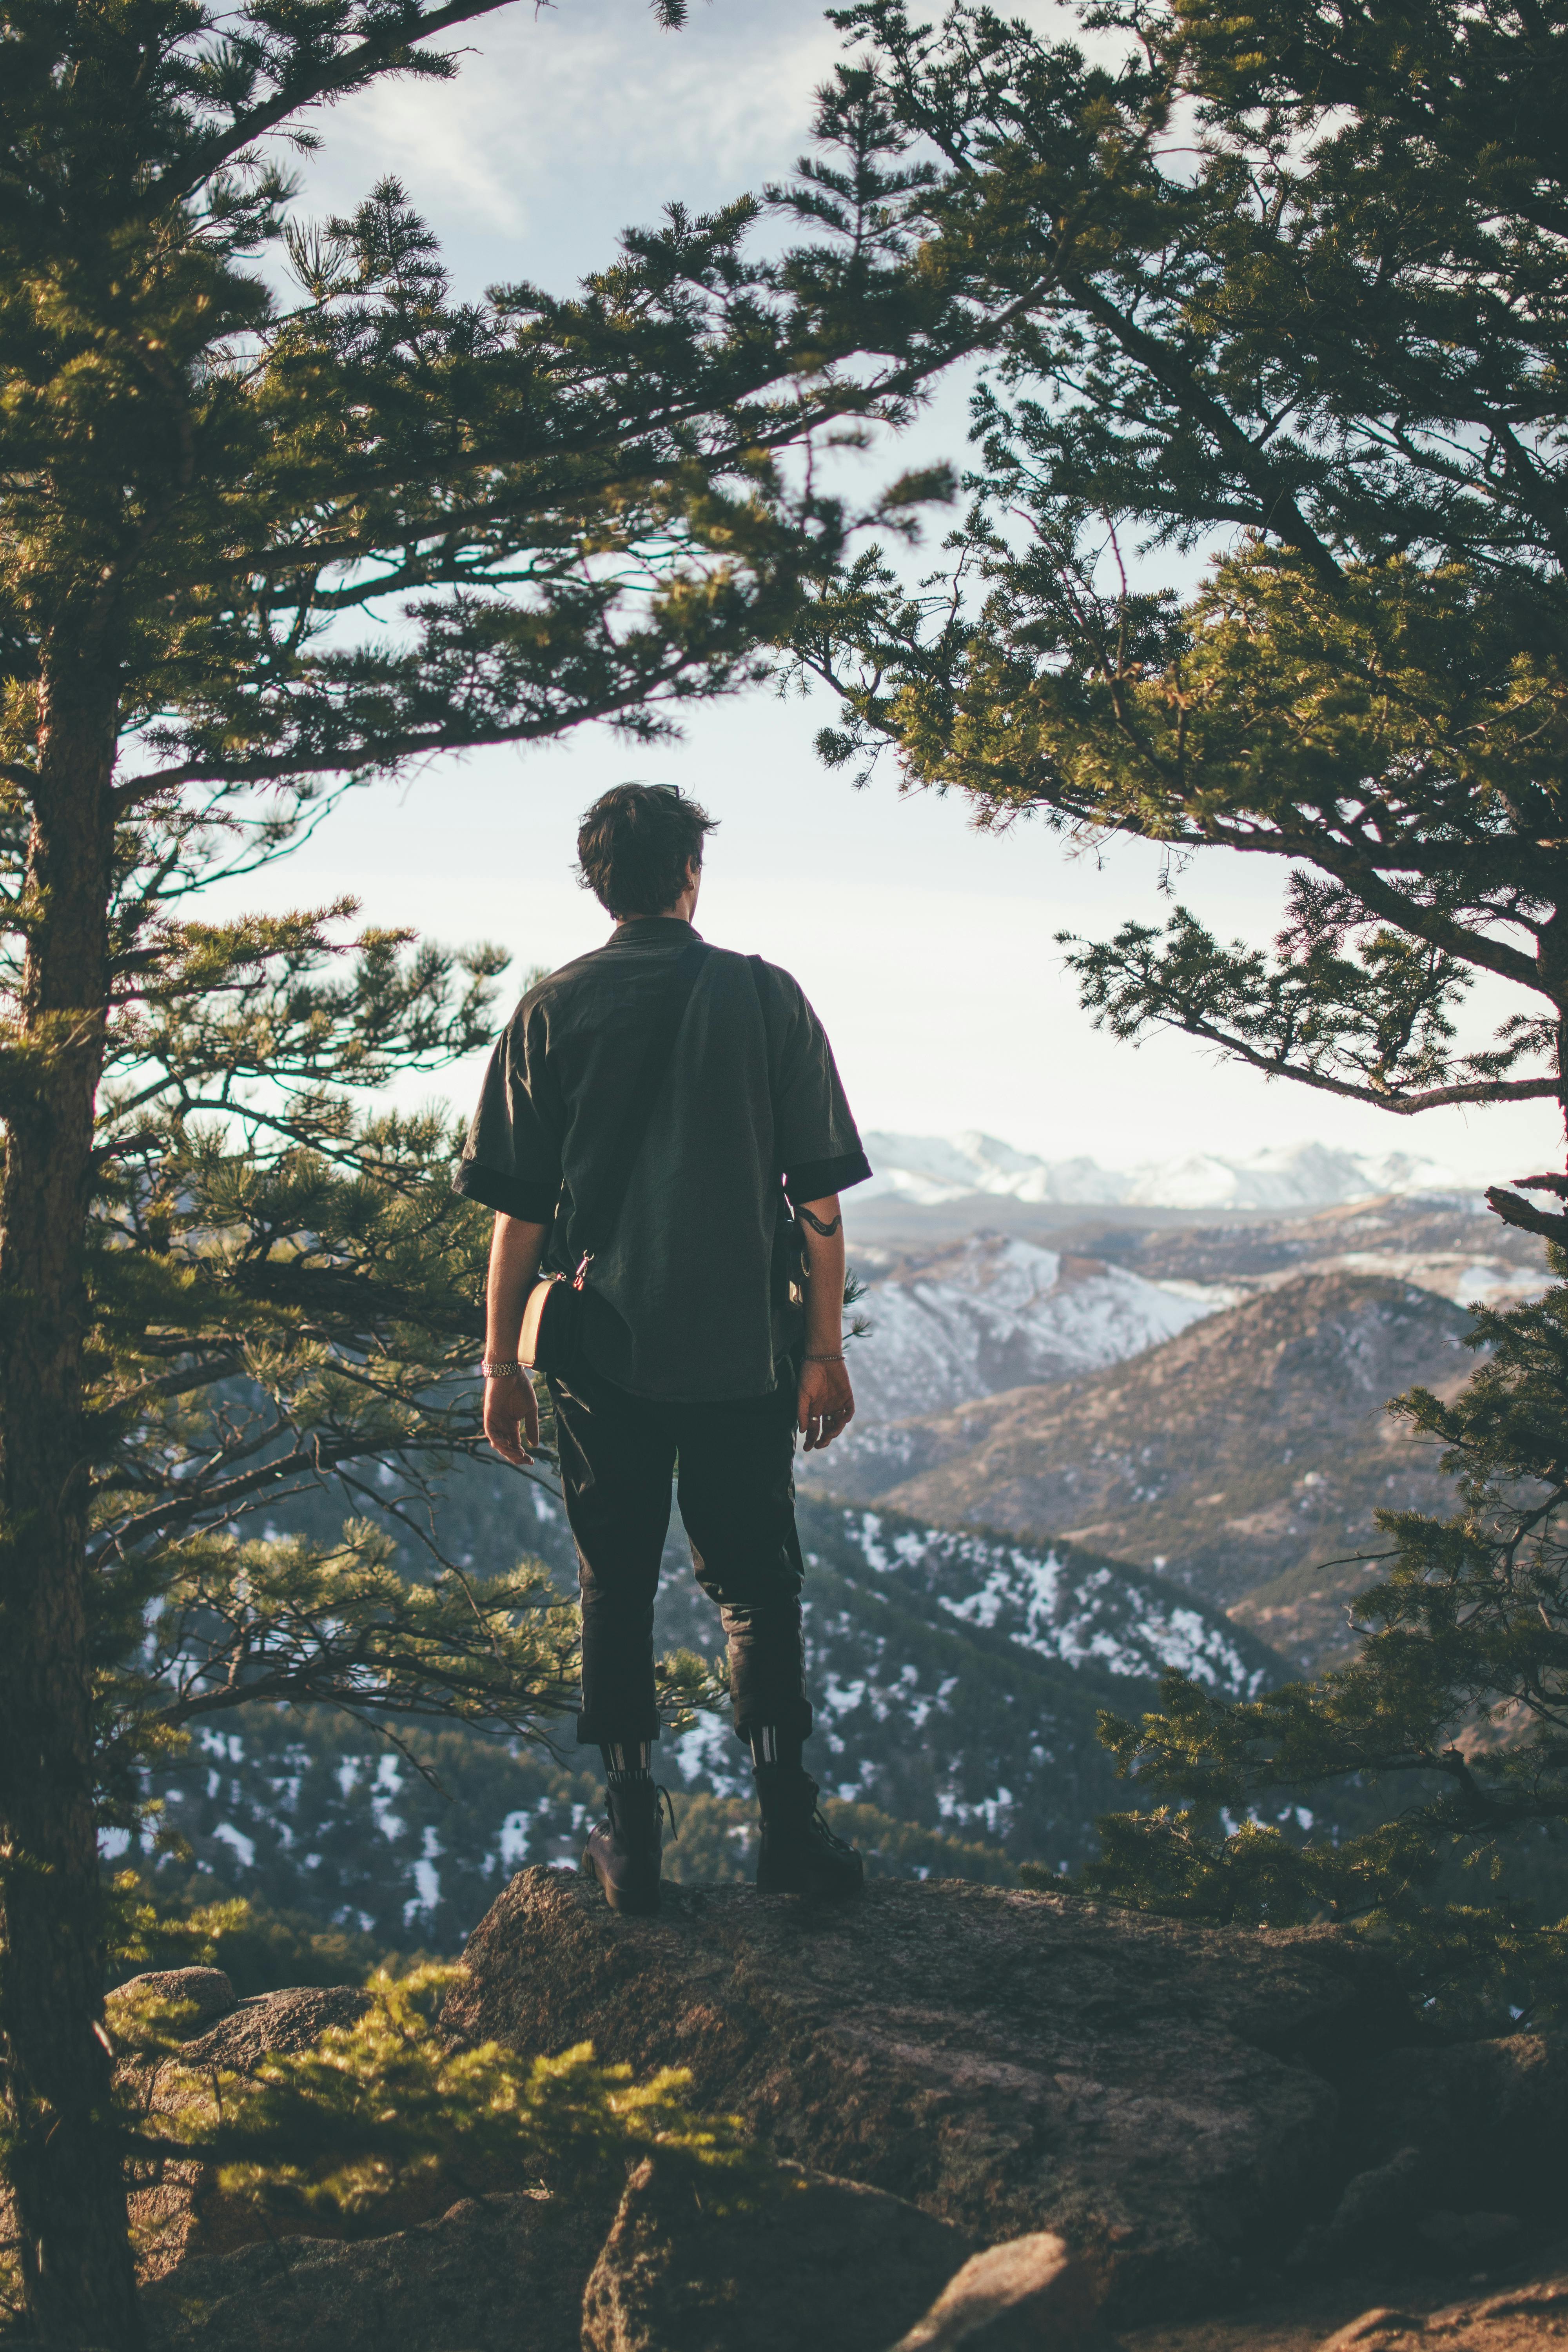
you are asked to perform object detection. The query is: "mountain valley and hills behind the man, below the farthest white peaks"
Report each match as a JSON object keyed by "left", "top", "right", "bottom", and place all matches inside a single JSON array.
[{"left": 148, "top": 1148, "right": 1542, "bottom": 1957}]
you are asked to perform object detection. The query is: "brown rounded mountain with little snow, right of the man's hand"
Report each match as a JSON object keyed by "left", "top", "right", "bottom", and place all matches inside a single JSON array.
[{"left": 816, "top": 1270, "right": 1474, "bottom": 1668}]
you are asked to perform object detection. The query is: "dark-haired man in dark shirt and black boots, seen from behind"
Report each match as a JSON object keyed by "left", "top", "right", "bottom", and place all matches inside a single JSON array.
[{"left": 454, "top": 783, "right": 870, "bottom": 1912}]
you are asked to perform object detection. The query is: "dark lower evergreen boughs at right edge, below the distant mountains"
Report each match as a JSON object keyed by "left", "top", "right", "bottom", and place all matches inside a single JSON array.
[{"left": 1086, "top": 1251, "right": 1568, "bottom": 2030}]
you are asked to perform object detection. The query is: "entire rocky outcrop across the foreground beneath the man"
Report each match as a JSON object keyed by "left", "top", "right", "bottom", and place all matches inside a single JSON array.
[{"left": 111, "top": 1910, "right": 1568, "bottom": 2352}]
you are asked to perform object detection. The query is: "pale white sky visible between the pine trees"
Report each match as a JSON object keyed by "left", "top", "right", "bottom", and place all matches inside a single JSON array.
[{"left": 202, "top": 0, "right": 1561, "bottom": 1176}]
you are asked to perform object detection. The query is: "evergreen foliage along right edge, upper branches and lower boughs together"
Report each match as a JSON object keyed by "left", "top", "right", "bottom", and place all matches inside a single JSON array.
[{"left": 797, "top": 0, "right": 1568, "bottom": 2025}]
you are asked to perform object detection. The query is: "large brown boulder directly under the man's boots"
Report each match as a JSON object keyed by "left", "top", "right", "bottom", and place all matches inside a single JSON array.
[{"left": 446, "top": 1870, "right": 1417, "bottom": 2314}]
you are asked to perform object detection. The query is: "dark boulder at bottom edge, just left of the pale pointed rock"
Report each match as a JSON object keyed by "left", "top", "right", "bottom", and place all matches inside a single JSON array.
[{"left": 583, "top": 2161, "right": 971, "bottom": 2352}]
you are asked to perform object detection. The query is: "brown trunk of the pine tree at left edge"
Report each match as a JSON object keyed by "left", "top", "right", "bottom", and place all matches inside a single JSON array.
[{"left": 0, "top": 663, "right": 141, "bottom": 2352}]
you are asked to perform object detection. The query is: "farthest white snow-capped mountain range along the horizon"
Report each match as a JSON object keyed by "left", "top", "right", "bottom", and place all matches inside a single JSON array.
[{"left": 856, "top": 1131, "right": 1479, "bottom": 1209}]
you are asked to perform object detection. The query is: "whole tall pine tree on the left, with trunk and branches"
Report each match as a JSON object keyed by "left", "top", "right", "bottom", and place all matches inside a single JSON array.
[{"left": 0, "top": 0, "right": 976, "bottom": 2347}]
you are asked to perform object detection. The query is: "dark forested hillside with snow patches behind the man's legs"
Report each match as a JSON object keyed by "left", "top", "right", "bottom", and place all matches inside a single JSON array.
[{"left": 138, "top": 1465, "right": 1279, "bottom": 1950}]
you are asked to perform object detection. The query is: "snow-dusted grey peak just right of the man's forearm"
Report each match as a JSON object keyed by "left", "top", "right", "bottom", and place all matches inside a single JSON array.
[{"left": 851, "top": 1232, "right": 1241, "bottom": 1425}]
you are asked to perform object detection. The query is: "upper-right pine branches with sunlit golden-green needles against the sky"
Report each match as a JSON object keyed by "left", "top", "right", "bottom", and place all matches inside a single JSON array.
[{"left": 797, "top": 0, "right": 1568, "bottom": 1195}]
